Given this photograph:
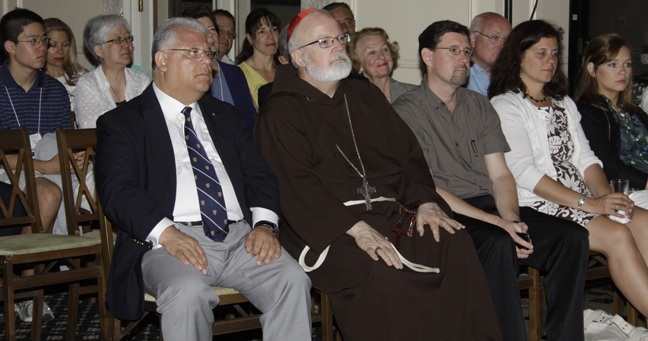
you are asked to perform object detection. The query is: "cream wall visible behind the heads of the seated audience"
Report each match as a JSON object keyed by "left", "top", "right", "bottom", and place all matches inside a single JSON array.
[{"left": 0, "top": 0, "right": 569, "bottom": 84}]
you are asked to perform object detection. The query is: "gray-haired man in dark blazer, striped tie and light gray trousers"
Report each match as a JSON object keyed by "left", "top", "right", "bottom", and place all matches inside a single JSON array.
[{"left": 96, "top": 18, "right": 311, "bottom": 340}]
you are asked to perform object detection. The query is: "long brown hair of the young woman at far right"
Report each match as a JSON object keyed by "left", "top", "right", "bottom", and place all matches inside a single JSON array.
[{"left": 576, "top": 33, "right": 635, "bottom": 112}]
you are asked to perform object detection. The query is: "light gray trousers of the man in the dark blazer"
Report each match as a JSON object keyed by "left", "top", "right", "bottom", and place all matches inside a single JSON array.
[{"left": 142, "top": 222, "right": 311, "bottom": 341}]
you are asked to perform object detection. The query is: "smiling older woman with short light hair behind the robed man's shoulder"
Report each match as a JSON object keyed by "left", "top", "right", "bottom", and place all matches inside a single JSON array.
[{"left": 349, "top": 27, "right": 415, "bottom": 103}]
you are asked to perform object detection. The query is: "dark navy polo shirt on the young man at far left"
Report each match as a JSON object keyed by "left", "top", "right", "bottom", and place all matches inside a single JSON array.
[{"left": 0, "top": 61, "right": 72, "bottom": 135}]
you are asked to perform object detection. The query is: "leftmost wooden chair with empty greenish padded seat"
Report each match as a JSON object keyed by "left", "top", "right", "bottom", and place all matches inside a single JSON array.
[{"left": 0, "top": 128, "right": 105, "bottom": 340}]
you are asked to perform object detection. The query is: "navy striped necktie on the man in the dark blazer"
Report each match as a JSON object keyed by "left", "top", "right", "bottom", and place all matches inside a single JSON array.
[{"left": 182, "top": 107, "right": 229, "bottom": 242}]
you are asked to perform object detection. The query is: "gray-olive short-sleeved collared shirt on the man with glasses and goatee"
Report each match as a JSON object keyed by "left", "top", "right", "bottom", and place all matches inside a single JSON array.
[{"left": 394, "top": 76, "right": 510, "bottom": 198}]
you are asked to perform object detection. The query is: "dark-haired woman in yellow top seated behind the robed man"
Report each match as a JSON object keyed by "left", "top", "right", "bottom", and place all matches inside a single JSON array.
[{"left": 236, "top": 8, "right": 281, "bottom": 111}]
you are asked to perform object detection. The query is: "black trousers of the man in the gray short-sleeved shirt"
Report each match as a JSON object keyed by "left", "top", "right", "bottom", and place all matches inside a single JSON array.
[{"left": 455, "top": 195, "right": 589, "bottom": 341}]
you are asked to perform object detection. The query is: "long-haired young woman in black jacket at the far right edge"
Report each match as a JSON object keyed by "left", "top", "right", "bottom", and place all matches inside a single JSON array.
[{"left": 576, "top": 34, "right": 648, "bottom": 193}]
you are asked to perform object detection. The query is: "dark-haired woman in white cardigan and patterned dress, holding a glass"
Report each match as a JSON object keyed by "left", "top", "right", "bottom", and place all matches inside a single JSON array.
[{"left": 488, "top": 20, "right": 648, "bottom": 316}]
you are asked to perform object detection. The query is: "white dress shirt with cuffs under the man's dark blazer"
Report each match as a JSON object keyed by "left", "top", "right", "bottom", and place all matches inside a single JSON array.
[{"left": 147, "top": 84, "right": 254, "bottom": 247}]
